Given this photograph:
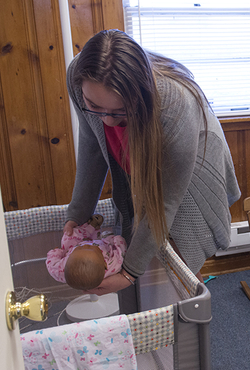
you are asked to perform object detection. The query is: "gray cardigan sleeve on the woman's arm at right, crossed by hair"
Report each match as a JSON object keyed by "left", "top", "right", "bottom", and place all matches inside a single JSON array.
[{"left": 123, "top": 78, "right": 203, "bottom": 276}]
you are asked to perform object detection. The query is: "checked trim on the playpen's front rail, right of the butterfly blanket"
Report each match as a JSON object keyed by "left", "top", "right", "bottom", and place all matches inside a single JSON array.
[{"left": 128, "top": 305, "right": 174, "bottom": 355}]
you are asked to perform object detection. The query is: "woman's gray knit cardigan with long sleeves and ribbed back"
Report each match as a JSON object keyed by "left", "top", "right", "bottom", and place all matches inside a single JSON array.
[{"left": 67, "top": 57, "right": 240, "bottom": 277}]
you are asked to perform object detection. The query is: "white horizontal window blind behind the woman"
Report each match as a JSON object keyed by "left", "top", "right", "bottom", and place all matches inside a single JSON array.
[{"left": 123, "top": 0, "right": 250, "bottom": 116}]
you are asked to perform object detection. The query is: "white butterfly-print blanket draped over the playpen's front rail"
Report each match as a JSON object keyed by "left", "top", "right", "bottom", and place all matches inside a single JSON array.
[{"left": 21, "top": 315, "right": 137, "bottom": 370}]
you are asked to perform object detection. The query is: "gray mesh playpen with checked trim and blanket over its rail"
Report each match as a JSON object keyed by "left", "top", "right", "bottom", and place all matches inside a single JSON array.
[{"left": 5, "top": 199, "right": 211, "bottom": 370}]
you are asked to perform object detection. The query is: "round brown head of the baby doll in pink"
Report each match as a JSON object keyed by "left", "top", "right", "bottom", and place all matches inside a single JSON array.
[{"left": 64, "top": 243, "right": 107, "bottom": 290}]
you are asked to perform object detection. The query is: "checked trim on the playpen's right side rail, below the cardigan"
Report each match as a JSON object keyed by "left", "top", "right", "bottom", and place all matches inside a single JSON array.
[{"left": 158, "top": 242, "right": 199, "bottom": 297}]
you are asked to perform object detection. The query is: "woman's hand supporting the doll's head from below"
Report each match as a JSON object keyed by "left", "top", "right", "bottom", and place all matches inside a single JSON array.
[{"left": 83, "top": 270, "right": 135, "bottom": 296}]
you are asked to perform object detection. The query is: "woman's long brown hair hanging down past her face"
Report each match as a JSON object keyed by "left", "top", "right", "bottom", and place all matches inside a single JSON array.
[{"left": 75, "top": 30, "right": 209, "bottom": 245}]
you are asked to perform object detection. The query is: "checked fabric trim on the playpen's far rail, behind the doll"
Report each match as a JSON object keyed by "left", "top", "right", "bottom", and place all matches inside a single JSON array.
[{"left": 4, "top": 199, "right": 114, "bottom": 240}]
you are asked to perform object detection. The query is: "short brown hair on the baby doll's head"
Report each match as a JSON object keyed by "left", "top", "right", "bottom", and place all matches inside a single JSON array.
[{"left": 64, "top": 251, "right": 105, "bottom": 290}]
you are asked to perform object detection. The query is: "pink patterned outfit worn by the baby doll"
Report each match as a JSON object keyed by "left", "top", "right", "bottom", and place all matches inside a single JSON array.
[{"left": 46, "top": 223, "right": 126, "bottom": 283}]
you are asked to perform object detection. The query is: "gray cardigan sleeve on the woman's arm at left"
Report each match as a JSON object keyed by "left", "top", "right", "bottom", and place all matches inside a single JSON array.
[{"left": 67, "top": 58, "right": 108, "bottom": 225}]
